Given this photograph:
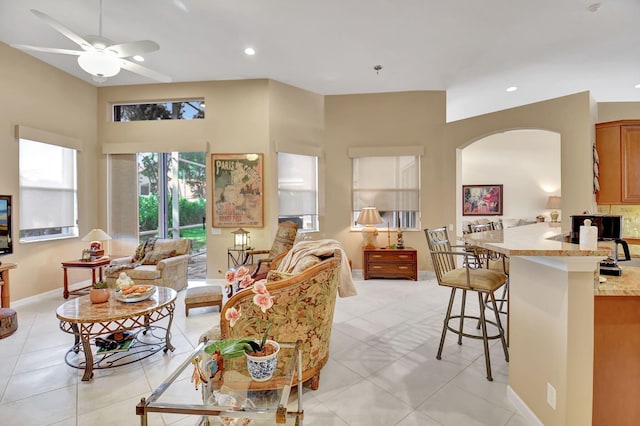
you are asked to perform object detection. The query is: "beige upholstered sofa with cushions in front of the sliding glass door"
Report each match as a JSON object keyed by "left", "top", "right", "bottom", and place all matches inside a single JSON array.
[{"left": 105, "top": 238, "right": 191, "bottom": 291}]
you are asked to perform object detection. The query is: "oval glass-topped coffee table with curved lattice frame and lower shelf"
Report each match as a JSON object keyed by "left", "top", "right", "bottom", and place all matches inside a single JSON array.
[{"left": 56, "top": 286, "right": 176, "bottom": 381}]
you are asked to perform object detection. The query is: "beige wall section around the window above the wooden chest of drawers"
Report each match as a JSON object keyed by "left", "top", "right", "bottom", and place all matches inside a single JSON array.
[{"left": 324, "top": 91, "right": 444, "bottom": 269}]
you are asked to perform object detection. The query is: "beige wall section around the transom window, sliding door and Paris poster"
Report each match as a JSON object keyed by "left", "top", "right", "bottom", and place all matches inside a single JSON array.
[{"left": 98, "top": 80, "right": 276, "bottom": 278}]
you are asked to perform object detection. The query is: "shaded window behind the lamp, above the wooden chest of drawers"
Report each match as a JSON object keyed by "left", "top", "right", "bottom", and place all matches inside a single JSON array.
[{"left": 351, "top": 155, "right": 420, "bottom": 229}]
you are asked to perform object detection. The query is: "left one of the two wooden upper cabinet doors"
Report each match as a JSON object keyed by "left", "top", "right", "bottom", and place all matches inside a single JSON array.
[{"left": 596, "top": 125, "right": 622, "bottom": 204}]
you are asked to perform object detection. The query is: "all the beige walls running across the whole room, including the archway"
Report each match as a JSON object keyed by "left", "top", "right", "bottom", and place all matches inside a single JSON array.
[{"left": 5, "top": 38, "right": 640, "bottom": 300}]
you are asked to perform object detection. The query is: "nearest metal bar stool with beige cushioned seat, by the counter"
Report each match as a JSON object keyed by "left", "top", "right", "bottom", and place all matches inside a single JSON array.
[{"left": 424, "top": 227, "right": 509, "bottom": 381}]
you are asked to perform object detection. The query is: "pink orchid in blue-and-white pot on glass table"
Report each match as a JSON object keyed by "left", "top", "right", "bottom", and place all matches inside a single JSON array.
[{"left": 204, "top": 267, "right": 280, "bottom": 381}]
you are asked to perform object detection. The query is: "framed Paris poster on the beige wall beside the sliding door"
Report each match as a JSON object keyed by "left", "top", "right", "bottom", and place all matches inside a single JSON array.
[{"left": 211, "top": 154, "right": 264, "bottom": 228}]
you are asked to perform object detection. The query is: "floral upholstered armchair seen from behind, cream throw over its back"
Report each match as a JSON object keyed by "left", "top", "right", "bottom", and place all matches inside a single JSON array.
[{"left": 203, "top": 246, "right": 352, "bottom": 389}]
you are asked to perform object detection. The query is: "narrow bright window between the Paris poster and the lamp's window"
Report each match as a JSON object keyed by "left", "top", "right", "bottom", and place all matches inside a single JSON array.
[{"left": 278, "top": 152, "right": 318, "bottom": 232}]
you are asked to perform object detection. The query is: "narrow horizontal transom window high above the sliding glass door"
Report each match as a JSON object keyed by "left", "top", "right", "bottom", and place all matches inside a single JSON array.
[{"left": 113, "top": 99, "right": 205, "bottom": 121}]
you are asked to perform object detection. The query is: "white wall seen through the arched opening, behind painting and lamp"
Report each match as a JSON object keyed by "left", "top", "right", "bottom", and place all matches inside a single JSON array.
[{"left": 458, "top": 130, "right": 561, "bottom": 231}]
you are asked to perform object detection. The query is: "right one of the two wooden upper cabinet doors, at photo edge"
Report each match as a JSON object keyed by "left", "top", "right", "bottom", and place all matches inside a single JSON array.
[{"left": 621, "top": 125, "right": 640, "bottom": 204}]
